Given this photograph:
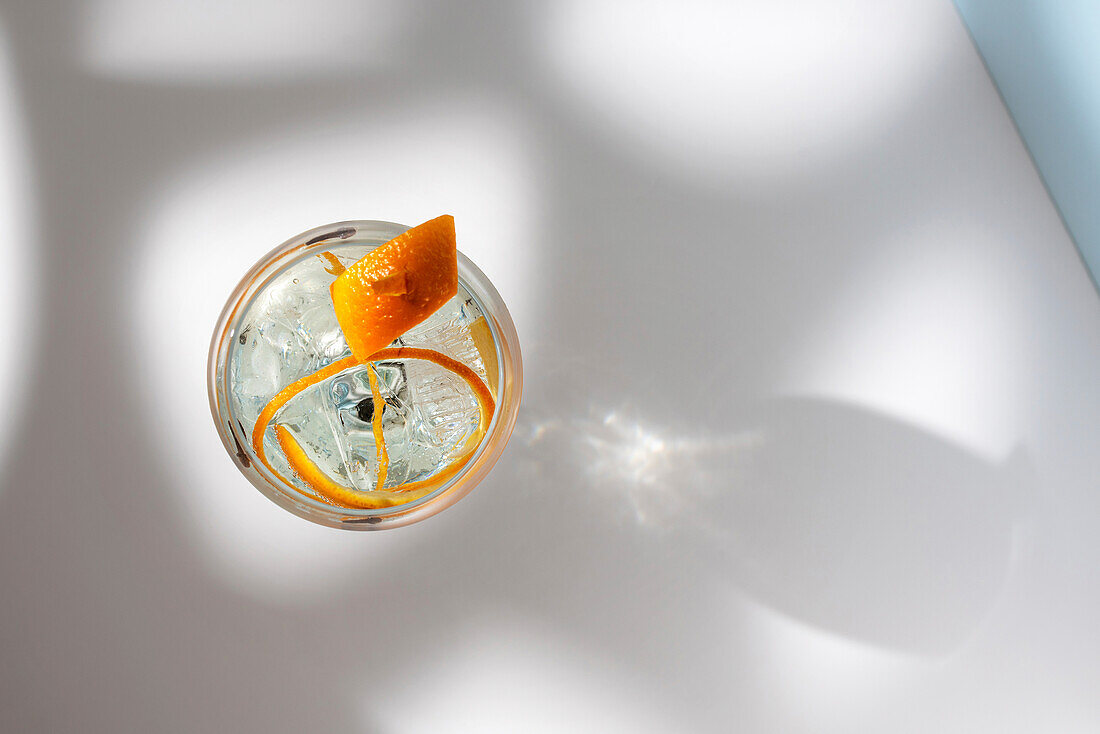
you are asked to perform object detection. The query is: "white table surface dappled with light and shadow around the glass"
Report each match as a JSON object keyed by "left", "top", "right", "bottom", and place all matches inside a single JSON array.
[{"left": 0, "top": 0, "right": 1100, "bottom": 734}]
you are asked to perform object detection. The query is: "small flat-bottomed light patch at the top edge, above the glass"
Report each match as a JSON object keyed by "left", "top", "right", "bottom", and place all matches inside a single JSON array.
[{"left": 76, "top": 0, "right": 415, "bottom": 85}]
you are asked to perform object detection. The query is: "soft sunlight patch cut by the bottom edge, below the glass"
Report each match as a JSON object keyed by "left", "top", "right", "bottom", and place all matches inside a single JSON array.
[{"left": 360, "top": 614, "right": 678, "bottom": 734}]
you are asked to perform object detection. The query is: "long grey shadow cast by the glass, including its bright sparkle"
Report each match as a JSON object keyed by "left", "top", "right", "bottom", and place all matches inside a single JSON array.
[{"left": 514, "top": 356, "right": 1035, "bottom": 657}]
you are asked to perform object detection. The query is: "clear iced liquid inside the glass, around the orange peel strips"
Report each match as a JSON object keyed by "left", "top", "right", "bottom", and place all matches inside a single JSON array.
[{"left": 229, "top": 244, "right": 495, "bottom": 490}]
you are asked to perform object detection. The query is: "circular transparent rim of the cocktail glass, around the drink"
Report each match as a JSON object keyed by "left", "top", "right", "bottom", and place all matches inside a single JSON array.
[{"left": 207, "top": 220, "right": 523, "bottom": 529}]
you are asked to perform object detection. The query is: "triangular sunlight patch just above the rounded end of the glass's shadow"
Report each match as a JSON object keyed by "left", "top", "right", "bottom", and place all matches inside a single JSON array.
[{"left": 787, "top": 227, "right": 1030, "bottom": 460}]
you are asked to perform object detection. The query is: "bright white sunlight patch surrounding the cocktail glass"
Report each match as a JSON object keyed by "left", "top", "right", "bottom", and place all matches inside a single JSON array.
[{"left": 133, "top": 101, "right": 536, "bottom": 601}]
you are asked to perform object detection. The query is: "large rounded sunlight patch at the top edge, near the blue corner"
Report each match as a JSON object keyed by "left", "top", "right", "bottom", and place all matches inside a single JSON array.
[{"left": 540, "top": 0, "right": 946, "bottom": 178}]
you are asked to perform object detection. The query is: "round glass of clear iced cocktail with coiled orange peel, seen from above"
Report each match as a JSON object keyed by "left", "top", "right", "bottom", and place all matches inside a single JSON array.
[{"left": 210, "top": 217, "right": 520, "bottom": 527}]
